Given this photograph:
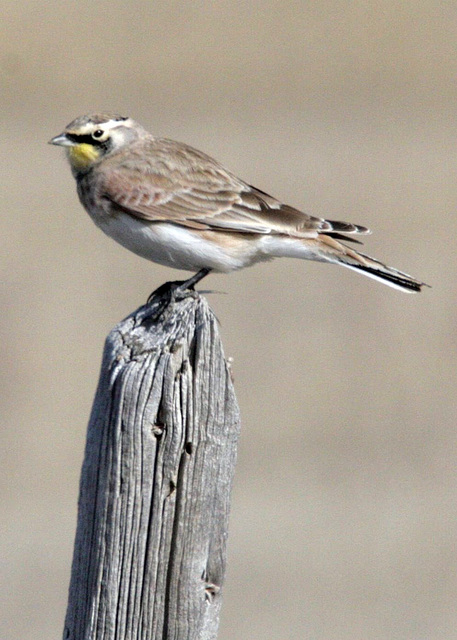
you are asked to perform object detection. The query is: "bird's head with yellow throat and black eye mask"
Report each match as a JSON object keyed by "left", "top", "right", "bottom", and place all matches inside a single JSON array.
[{"left": 49, "top": 114, "right": 144, "bottom": 175}]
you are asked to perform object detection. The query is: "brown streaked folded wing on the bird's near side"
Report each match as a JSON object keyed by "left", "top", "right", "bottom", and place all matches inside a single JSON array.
[{"left": 98, "top": 152, "right": 365, "bottom": 239}]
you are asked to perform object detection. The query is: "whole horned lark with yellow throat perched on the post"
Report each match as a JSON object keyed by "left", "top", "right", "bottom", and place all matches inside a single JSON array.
[{"left": 50, "top": 114, "right": 424, "bottom": 292}]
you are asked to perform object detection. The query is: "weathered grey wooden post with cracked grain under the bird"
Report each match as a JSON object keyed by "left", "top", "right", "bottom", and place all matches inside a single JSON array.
[{"left": 64, "top": 290, "right": 239, "bottom": 640}]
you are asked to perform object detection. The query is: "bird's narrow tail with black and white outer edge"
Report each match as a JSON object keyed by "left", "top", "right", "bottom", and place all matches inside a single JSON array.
[{"left": 319, "top": 234, "right": 429, "bottom": 293}]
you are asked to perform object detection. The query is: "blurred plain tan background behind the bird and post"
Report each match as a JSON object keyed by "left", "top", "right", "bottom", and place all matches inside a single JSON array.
[{"left": 0, "top": 0, "right": 457, "bottom": 640}]
